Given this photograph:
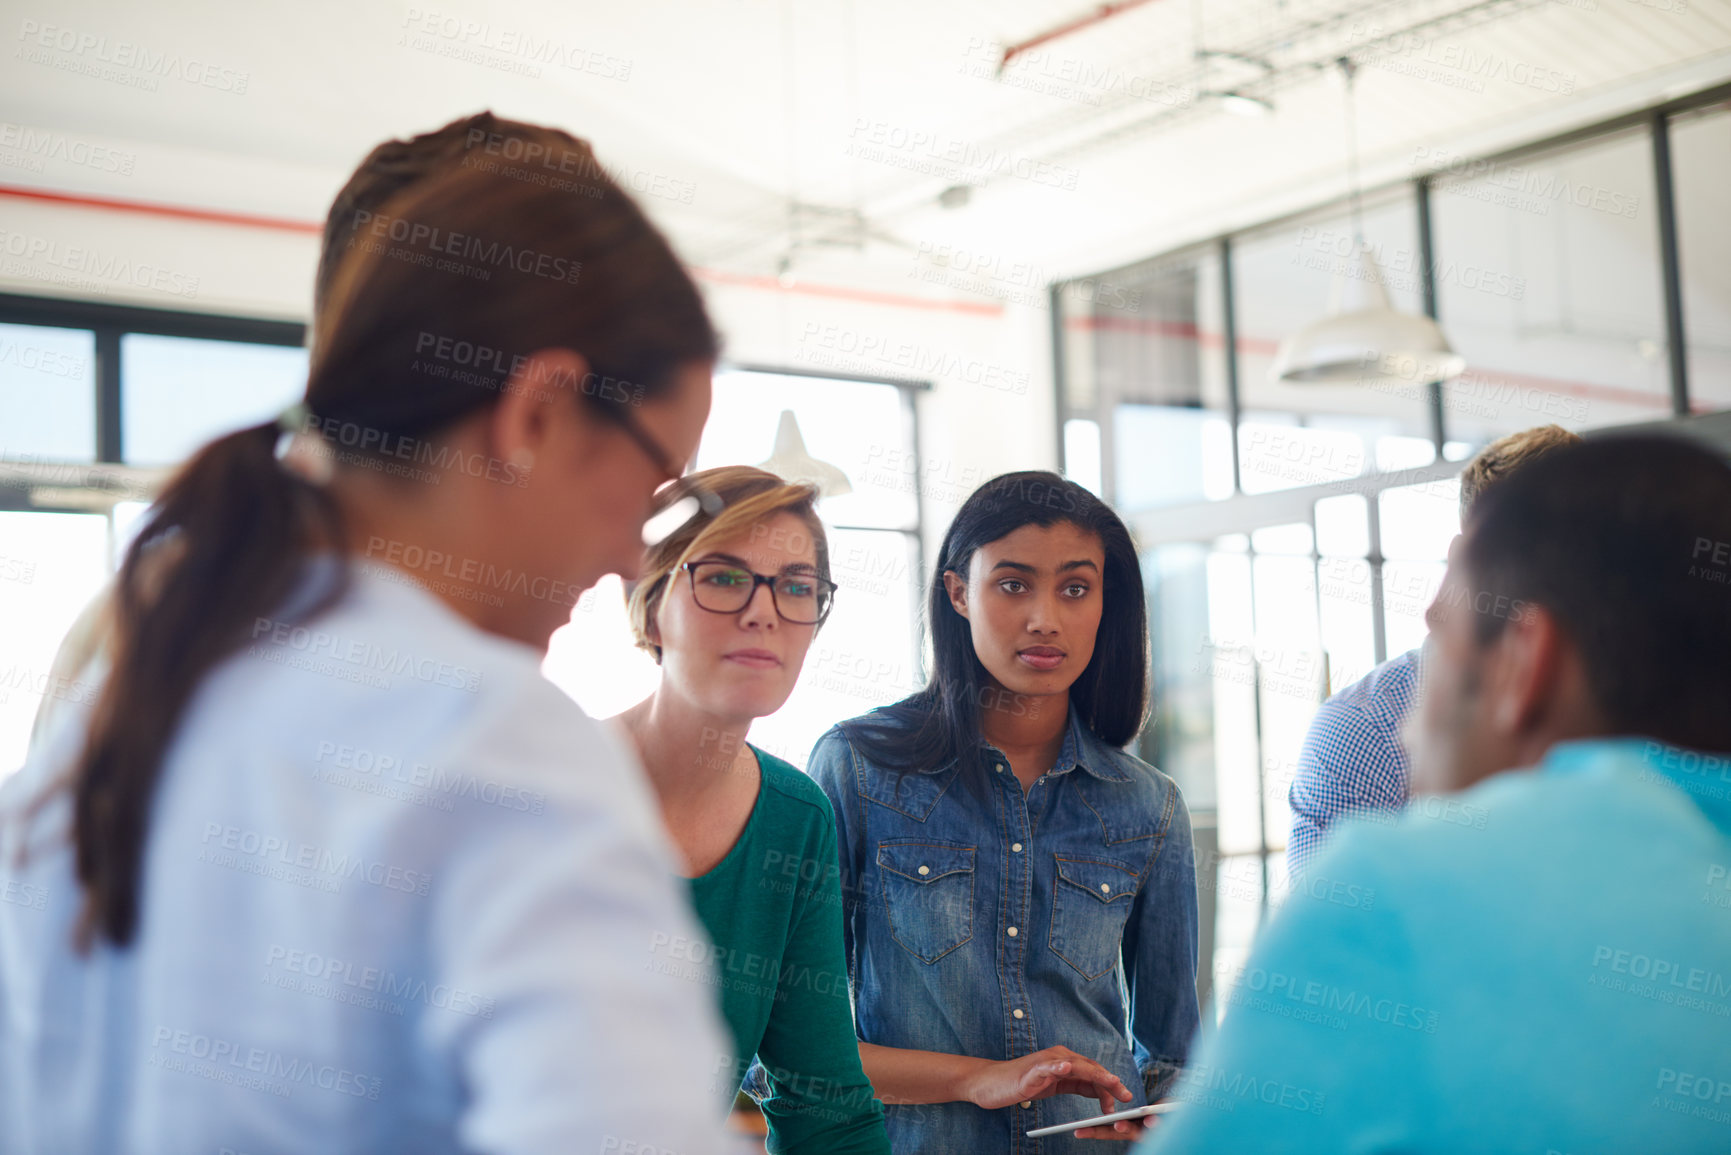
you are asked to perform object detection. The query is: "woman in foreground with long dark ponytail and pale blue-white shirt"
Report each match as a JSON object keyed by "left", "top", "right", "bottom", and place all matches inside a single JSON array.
[{"left": 0, "top": 118, "right": 730, "bottom": 1153}]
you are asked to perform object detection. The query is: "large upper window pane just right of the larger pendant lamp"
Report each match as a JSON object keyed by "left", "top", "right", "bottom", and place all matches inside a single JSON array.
[{"left": 1432, "top": 130, "right": 1670, "bottom": 443}]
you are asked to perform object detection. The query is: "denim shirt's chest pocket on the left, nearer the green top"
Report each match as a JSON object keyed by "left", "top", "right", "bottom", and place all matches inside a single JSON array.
[{"left": 878, "top": 838, "right": 975, "bottom": 963}]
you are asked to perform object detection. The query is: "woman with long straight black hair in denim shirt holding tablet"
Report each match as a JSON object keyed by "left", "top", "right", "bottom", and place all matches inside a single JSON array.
[{"left": 808, "top": 473, "right": 1198, "bottom": 1155}]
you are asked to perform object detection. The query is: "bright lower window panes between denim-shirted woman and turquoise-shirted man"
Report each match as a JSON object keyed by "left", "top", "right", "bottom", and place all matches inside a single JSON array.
[{"left": 1130, "top": 464, "right": 1459, "bottom": 997}]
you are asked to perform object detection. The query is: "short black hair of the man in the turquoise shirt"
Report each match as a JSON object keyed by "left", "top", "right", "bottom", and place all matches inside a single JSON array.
[{"left": 1459, "top": 435, "right": 1731, "bottom": 750}]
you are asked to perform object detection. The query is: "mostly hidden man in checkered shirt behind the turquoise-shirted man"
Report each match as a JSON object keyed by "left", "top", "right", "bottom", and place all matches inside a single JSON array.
[{"left": 1286, "top": 424, "right": 1580, "bottom": 878}]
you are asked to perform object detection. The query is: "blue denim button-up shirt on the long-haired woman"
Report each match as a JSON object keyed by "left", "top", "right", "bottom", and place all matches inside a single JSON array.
[{"left": 807, "top": 707, "right": 1200, "bottom": 1155}]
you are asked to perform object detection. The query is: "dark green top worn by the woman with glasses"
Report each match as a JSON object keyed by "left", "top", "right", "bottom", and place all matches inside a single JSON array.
[{"left": 691, "top": 746, "right": 890, "bottom": 1155}]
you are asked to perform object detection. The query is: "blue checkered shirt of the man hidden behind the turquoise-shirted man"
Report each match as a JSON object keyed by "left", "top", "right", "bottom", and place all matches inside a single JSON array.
[{"left": 1286, "top": 649, "right": 1423, "bottom": 874}]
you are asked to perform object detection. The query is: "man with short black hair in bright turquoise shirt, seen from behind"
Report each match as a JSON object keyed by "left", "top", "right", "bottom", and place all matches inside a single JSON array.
[{"left": 1148, "top": 436, "right": 1731, "bottom": 1155}]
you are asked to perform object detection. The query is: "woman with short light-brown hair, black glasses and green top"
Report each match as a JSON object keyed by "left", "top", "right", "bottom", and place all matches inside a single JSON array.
[{"left": 621, "top": 466, "right": 890, "bottom": 1155}]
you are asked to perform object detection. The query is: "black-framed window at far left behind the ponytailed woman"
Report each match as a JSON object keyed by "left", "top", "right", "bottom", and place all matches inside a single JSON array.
[{"left": 0, "top": 296, "right": 306, "bottom": 778}]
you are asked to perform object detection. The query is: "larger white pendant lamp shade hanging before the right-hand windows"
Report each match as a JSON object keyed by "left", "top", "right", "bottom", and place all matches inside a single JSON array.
[{"left": 1269, "top": 248, "right": 1466, "bottom": 386}]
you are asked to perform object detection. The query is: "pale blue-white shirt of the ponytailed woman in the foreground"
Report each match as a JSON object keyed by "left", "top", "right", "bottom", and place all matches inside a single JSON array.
[{"left": 0, "top": 566, "right": 734, "bottom": 1155}]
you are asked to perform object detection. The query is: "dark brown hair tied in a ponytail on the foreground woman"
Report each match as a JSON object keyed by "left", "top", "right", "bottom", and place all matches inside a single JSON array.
[{"left": 61, "top": 114, "right": 718, "bottom": 949}]
